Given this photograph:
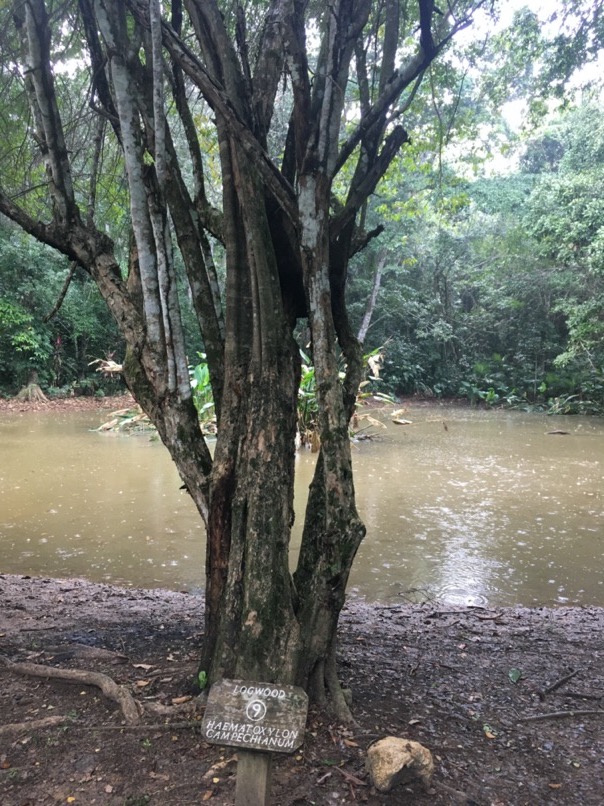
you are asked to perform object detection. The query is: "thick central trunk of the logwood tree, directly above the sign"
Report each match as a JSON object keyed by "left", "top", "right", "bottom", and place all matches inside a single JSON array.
[{"left": 202, "top": 144, "right": 300, "bottom": 682}]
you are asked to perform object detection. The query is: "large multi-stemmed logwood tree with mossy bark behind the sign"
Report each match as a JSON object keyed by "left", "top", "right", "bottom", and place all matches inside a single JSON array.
[{"left": 0, "top": 0, "right": 482, "bottom": 714}]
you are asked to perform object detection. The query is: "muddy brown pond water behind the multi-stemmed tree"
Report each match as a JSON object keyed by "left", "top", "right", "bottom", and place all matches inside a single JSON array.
[{"left": 0, "top": 407, "right": 604, "bottom": 606}]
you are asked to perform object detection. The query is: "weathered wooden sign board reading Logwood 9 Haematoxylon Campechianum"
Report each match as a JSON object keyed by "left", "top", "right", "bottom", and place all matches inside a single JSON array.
[{"left": 201, "top": 680, "right": 308, "bottom": 753}]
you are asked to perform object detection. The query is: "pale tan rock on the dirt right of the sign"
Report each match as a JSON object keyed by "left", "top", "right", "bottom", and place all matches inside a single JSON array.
[{"left": 366, "top": 736, "right": 434, "bottom": 792}]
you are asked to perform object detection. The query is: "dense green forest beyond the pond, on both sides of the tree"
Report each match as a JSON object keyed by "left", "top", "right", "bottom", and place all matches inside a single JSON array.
[{"left": 0, "top": 4, "right": 604, "bottom": 413}]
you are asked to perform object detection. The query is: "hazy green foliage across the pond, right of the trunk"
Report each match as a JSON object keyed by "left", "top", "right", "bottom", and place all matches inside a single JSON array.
[{"left": 349, "top": 104, "right": 604, "bottom": 411}]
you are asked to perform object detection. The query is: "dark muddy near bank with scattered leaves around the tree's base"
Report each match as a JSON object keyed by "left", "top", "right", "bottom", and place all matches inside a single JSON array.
[{"left": 0, "top": 575, "right": 604, "bottom": 806}]
